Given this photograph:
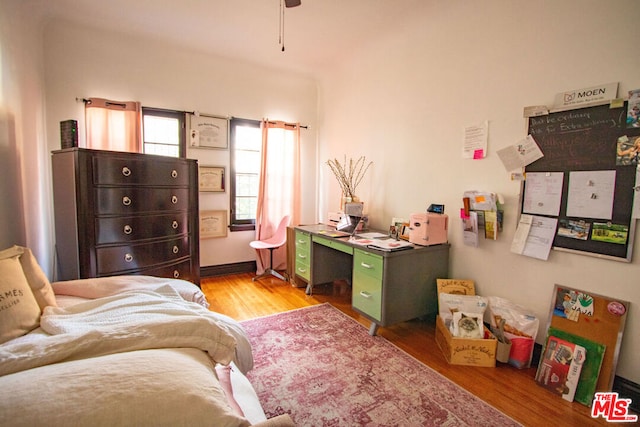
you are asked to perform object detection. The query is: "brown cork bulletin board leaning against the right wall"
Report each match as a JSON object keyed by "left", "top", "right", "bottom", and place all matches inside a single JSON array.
[{"left": 547, "top": 285, "right": 629, "bottom": 392}]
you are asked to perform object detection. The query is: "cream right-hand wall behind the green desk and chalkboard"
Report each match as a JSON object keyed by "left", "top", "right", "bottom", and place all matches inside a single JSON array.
[{"left": 319, "top": 0, "right": 640, "bottom": 382}]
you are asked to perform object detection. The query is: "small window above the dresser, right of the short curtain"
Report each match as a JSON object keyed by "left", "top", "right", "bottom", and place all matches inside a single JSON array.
[{"left": 142, "top": 107, "right": 186, "bottom": 157}]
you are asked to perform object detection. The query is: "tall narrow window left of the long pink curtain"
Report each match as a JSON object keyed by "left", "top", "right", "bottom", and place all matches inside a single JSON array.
[{"left": 229, "top": 118, "right": 262, "bottom": 231}]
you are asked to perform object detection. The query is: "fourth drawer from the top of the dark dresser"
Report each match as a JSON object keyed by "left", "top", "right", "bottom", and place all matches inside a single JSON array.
[{"left": 96, "top": 236, "right": 190, "bottom": 276}]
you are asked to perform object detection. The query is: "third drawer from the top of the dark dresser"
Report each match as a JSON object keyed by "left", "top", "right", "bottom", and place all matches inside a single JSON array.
[{"left": 96, "top": 212, "right": 189, "bottom": 245}]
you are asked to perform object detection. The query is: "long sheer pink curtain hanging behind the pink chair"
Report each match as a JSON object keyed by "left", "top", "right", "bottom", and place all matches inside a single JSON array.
[{"left": 256, "top": 120, "right": 300, "bottom": 274}]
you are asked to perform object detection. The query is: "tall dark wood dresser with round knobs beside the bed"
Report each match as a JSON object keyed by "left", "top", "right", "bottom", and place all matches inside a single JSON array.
[{"left": 52, "top": 148, "right": 200, "bottom": 285}]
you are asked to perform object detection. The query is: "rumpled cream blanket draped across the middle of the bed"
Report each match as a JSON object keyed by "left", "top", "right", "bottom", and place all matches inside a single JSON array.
[{"left": 0, "top": 286, "right": 236, "bottom": 376}]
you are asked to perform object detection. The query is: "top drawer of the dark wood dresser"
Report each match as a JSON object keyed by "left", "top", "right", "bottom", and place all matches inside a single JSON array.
[{"left": 93, "top": 156, "right": 189, "bottom": 186}]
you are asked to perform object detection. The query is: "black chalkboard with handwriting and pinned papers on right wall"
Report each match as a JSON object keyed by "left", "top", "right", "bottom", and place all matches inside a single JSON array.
[{"left": 520, "top": 102, "right": 640, "bottom": 262}]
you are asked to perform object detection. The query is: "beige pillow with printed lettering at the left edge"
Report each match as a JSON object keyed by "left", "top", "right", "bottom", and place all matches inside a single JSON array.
[{"left": 0, "top": 256, "right": 40, "bottom": 344}]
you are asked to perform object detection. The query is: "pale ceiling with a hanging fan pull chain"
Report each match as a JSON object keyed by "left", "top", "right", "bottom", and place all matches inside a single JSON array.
[{"left": 37, "top": 0, "right": 432, "bottom": 75}]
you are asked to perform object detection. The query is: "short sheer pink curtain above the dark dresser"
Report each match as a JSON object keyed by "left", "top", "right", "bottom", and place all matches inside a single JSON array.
[{"left": 84, "top": 98, "right": 142, "bottom": 153}]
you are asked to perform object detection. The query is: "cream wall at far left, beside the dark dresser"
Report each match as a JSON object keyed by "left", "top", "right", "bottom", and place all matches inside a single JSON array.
[{"left": 0, "top": 0, "right": 53, "bottom": 274}]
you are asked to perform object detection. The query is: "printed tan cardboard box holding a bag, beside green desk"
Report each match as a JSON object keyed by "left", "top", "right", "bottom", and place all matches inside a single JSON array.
[{"left": 436, "top": 279, "right": 498, "bottom": 368}]
